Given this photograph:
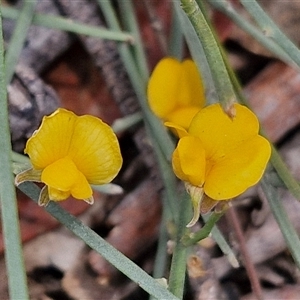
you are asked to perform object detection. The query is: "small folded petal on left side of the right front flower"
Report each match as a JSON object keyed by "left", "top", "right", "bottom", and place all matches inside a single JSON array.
[{"left": 172, "top": 136, "right": 206, "bottom": 186}]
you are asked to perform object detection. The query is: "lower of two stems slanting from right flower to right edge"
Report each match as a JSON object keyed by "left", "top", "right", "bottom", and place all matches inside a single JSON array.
[{"left": 261, "top": 173, "right": 300, "bottom": 269}]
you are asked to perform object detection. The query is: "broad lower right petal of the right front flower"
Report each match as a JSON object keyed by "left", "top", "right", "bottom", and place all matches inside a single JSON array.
[{"left": 204, "top": 135, "right": 271, "bottom": 200}]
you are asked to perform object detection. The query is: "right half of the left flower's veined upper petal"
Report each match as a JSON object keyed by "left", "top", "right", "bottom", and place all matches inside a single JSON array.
[{"left": 68, "top": 115, "right": 122, "bottom": 184}]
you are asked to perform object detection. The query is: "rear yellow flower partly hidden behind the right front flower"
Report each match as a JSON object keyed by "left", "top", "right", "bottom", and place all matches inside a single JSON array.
[{"left": 147, "top": 57, "right": 205, "bottom": 129}]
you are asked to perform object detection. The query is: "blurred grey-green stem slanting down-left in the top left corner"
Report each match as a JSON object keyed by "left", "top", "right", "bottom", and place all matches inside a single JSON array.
[{"left": 5, "top": 0, "right": 37, "bottom": 84}]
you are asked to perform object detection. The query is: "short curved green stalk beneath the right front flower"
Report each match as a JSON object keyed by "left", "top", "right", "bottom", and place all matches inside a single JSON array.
[{"left": 182, "top": 211, "right": 224, "bottom": 246}]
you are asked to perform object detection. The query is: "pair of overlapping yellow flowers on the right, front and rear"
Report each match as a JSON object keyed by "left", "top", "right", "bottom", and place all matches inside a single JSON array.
[{"left": 148, "top": 58, "right": 271, "bottom": 224}]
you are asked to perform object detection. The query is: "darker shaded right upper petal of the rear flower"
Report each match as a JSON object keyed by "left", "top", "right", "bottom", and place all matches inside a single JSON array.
[{"left": 176, "top": 59, "right": 205, "bottom": 110}]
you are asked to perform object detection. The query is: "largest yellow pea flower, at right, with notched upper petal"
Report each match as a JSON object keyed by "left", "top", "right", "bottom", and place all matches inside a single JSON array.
[{"left": 166, "top": 104, "right": 271, "bottom": 225}]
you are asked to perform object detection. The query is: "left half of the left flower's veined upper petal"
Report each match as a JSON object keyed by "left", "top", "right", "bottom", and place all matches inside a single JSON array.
[{"left": 24, "top": 108, "right": 77, "bottom": 169}]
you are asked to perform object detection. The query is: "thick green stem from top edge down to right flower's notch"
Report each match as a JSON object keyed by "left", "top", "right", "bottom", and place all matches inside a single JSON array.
[{"left": 181, "top": 0, "right": 236, "bottom": 110}]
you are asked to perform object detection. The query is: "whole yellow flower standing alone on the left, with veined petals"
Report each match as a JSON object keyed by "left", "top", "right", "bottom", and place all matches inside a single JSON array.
[{"left": 16, "top": 108, "right": 122, "bottom": 205}]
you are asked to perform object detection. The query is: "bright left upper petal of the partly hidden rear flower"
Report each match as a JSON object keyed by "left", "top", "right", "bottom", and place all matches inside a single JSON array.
[{"left": 147, "top": 57, "right": 182, "bottom": 119}]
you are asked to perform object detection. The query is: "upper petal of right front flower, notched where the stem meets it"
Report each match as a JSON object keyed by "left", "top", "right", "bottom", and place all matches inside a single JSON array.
[{"left": 188, "top": 104, "right": 259, "bottom": 161}]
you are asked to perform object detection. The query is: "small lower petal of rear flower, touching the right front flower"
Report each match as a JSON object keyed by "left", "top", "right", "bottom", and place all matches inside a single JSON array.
[{"left": 167, "top": 106, "right": 200, "bottom": 129}]
